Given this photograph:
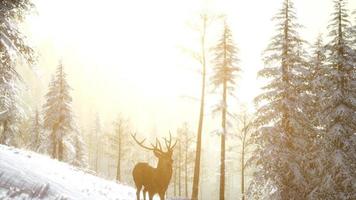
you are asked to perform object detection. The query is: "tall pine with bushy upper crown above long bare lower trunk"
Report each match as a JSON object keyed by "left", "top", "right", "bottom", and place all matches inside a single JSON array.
[{"left": 212, "top": 19, "right": 240, "bottom": 200}]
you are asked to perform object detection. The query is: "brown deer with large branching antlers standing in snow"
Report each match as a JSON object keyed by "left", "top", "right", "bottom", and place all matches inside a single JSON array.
[{"left": 131, "top": 133, "right": 177, "bottom": 200}]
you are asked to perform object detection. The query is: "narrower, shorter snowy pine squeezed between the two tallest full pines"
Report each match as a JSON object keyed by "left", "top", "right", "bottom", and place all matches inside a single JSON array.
[{"left": 303, "top": 35, "right": 327, "bottom": 199}]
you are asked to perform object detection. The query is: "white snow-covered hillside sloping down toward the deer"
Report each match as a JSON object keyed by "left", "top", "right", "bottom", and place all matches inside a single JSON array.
[{"left": 0, "top": 145, "right": 135, "bottom": 200}]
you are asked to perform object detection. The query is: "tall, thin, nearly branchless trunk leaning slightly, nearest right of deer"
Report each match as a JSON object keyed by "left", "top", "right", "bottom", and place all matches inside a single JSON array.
[{"left": 192, "top": 15, "right": 207, "bottom": 200}]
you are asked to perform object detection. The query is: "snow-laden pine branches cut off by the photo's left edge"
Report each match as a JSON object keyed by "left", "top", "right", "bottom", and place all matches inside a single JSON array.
[{"left": 0, "top": 0, "right": 35, "bottom": 144}]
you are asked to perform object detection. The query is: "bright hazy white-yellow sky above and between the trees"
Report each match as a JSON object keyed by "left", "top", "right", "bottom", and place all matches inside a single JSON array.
[{"left": 26, "top": 0, "right": 356, "bottom": 136}]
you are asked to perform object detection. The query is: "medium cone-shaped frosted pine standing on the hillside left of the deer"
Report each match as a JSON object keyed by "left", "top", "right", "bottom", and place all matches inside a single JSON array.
[{"left": 43, "top": 63, "right": 76, "bottom": 161}]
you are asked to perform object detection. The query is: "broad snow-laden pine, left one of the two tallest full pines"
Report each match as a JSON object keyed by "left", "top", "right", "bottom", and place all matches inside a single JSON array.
[{"left": 247, "top": 0, "right": 312, "bottom": 199}]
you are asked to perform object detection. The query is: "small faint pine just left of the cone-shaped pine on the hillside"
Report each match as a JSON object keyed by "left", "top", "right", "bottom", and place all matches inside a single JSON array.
[{"left": 27, "top": 109, "right": 43, "bottom": 152}]
